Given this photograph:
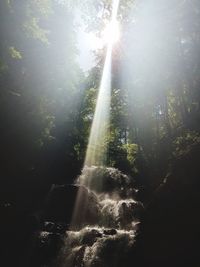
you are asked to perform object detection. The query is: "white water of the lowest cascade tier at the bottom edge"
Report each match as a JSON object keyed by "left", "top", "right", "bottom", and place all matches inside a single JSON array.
[{"left": 60, "top": 227, "right": 135, "bottom": 267}]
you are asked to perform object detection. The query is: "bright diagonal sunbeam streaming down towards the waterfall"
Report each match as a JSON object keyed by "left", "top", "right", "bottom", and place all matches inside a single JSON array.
[{"left": 71, "top": 0, "right": 119, "bottom": 227}]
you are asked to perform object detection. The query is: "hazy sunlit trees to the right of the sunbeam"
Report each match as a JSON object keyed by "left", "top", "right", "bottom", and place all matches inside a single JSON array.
[{"left": 78, "top": 0, "right": 200, "bottom": 182}]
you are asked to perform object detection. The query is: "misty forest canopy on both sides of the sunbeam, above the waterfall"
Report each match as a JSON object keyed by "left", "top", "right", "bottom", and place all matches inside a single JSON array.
[{"left": 0, "top": 0, "right": 200, "bottom": 205}]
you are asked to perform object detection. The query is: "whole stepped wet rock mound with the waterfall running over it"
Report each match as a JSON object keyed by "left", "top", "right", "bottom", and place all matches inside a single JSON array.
[{"left": 37, "top": 167, "right": 140, "bottom": 267}]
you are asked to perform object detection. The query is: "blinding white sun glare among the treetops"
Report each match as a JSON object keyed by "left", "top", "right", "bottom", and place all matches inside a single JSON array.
[{"left": 88, "top": 20, "right": 120, "bottom": 50}]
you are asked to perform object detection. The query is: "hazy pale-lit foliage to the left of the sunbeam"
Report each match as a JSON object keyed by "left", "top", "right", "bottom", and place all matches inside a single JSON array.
[{"left": 0, "top": 0, "right": 83, "bottom": 188}]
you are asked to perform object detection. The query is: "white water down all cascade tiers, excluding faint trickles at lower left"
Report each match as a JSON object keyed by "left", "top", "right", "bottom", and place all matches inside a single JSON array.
[{"left": 57, "top": 166, "right": 142, "bottom": 267}]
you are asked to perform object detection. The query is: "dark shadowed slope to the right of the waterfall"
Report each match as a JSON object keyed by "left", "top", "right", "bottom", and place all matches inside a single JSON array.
[{"left": 134, "top": 145, "right": 200, "bottom": 267}]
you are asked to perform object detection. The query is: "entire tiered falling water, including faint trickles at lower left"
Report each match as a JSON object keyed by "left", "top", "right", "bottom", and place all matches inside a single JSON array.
[{"left": 36, "top": 166, "right": 143, "bottom": 267}]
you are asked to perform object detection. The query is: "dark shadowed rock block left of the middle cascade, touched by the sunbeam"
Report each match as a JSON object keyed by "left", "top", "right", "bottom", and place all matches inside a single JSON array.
[{"left": 44, "top": 185, "right": 98, "bottom": 228}]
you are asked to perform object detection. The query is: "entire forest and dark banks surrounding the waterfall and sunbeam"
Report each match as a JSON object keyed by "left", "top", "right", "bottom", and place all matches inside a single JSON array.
[{"left": 0, "top": 0, "right": 200, "bottom": 267}]
